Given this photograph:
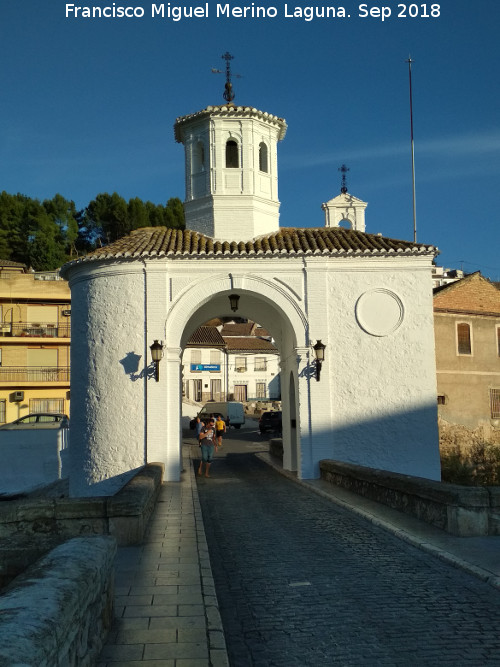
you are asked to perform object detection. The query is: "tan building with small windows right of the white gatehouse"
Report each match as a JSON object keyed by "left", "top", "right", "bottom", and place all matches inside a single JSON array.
[{"left": 434, "top": 273, "right": 500, "bottom": 440}]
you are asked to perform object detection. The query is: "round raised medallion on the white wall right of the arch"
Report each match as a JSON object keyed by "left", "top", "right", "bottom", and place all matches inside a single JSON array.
[{"left": 356, "top": 287, "right": 404, "bottom": 336}]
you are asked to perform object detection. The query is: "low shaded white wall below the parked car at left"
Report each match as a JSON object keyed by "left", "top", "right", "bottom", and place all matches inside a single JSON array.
[{"left": 0, "top": 425, "right": 69, "bottom": 493}]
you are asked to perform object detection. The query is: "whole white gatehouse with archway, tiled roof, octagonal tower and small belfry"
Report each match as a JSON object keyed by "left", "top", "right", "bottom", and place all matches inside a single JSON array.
[{"left": 63, "top": 92, "right": 440, "bottom": 497}]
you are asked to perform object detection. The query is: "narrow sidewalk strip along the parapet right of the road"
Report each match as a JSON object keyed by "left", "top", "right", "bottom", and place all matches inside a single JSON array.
[{"left": 257, "top": 453, "right": 500, "bottom": 588}]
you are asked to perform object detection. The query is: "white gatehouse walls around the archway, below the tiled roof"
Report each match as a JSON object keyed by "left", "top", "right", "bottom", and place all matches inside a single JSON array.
[{"left": 64, "top": 250, "right": 440, "bottom": 495}]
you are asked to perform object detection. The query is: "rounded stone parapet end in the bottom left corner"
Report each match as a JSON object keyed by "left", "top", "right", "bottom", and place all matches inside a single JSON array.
[{"left": 0, "top": 536, "right": 116, "bottom": 667}]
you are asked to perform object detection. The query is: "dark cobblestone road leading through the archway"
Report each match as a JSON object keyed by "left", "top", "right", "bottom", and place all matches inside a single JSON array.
[{"left": 194, "top": 433, "right": 500, "bottom": 667}]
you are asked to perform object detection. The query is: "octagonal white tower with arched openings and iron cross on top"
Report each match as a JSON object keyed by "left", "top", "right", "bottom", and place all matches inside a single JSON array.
[{"left": 174, "top": 53, "right": 287, "bottom": 241}]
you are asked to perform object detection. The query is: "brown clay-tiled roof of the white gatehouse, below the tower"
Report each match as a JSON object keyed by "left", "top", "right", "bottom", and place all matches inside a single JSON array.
[{"left": 62, "top": 225, "right": 438, "bottom": 274}]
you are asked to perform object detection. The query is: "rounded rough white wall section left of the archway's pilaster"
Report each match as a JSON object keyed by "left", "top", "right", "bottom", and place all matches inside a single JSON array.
[{"left": 70, "top": 262, "right": 147, "bottom": 496}]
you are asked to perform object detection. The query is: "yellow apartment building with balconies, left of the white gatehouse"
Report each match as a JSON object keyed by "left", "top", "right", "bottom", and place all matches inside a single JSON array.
[{"left": 0, "top": 260, "right": 71, "bottom": 423}]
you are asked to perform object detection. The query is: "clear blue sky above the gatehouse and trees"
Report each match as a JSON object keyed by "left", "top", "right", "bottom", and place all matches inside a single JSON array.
[{"left": 0, "top": 0, "right": 500, "bottom": 280}]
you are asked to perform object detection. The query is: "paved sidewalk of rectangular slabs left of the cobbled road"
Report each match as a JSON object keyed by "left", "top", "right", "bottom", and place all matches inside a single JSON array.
[{"left": 98, "top": 446, "right": 228, "bottom": 667}]
